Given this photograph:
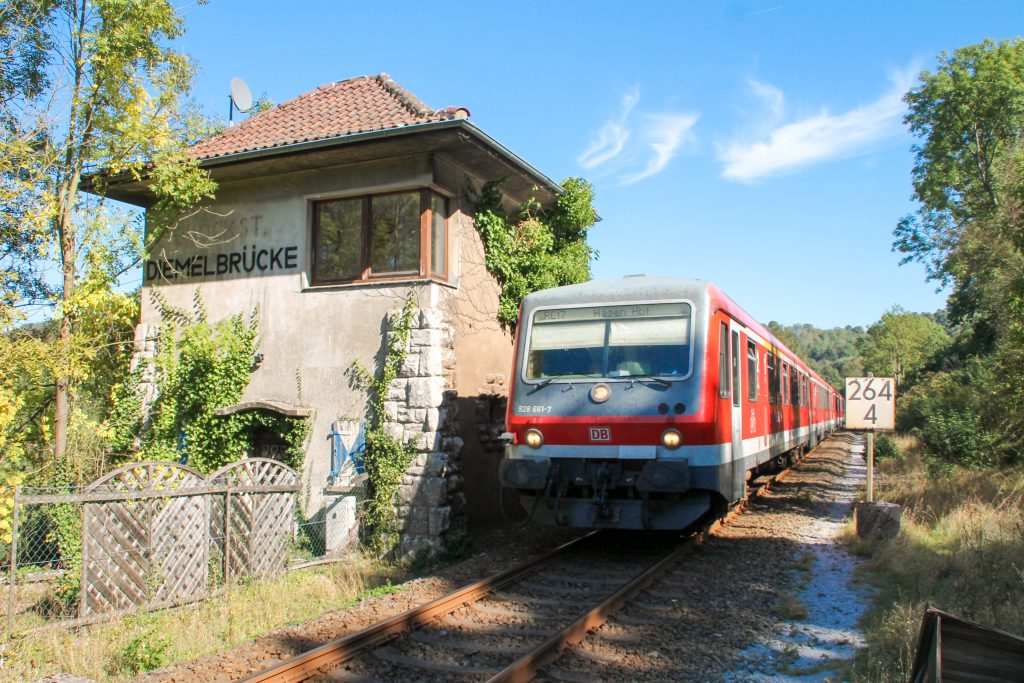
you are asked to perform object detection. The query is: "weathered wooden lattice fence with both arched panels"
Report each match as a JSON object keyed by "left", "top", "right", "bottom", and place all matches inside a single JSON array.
[{"left": 11, "top": 458, "right": 298, "bottom": 618}]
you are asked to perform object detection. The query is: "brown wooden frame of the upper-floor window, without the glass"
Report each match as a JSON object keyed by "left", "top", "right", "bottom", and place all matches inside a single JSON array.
[{"left": 309, "top": 187, "right": 451, "bottom": 287}]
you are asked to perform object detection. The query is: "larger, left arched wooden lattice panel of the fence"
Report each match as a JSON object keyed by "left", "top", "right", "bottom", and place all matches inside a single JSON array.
[{"left": 81, "top": 462, "right": 210, "bottom": 616}]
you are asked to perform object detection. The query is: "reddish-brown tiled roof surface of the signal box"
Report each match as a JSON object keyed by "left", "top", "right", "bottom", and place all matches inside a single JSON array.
[{"left": 189, "top": 74, "right": 469, "bottom": 160}]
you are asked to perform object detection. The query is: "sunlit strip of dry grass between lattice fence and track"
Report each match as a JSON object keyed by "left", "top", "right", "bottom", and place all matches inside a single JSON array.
[{"left": 3, "top": 558, "right": 397, "bottom": 681}]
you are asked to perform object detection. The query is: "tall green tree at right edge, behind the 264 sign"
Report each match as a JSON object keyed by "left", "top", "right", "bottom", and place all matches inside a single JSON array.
[{"left": 893, "top": 40, "right": 1024, "bottom": 463}]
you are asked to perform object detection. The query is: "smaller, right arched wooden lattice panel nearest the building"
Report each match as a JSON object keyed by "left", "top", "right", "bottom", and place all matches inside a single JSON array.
[{"left": 210, "top": 458, "right": 297, "bottom": 579}]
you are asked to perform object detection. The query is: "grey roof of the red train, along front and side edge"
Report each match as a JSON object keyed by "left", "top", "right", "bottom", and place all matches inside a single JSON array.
[{"left": 522, "top": 275, "right": 836, "bottom": 391}]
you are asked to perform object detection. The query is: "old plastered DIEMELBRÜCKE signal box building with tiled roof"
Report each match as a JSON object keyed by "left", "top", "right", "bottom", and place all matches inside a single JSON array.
[{"left": 109, "top": 74, "right": 558, "bottom": 553}]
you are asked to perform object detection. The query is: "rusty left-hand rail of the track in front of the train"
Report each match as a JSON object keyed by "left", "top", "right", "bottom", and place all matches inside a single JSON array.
[{"left": 243, "top": 531, "right": 599, "bottom": 683}]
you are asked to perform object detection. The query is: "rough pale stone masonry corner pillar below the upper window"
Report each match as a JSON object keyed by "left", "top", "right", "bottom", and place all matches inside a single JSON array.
[{"left": 384, "top": 308, "right": 466, "bottom": 556}]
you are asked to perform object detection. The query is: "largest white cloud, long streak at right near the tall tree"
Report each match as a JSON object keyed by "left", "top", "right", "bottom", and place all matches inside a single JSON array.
[{"left": 719, "top": 69, "right": 916, "bottom": 181}]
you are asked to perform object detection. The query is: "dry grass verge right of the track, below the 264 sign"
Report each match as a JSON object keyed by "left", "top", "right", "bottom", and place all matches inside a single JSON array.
[{"left": 844, "top": 437, "right": 1024, "bottom": 682}]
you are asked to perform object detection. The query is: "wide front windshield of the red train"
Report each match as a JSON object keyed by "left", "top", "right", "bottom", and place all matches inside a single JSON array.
[{"left": 526, "top": 302, "right": 692, "bottom": 381}]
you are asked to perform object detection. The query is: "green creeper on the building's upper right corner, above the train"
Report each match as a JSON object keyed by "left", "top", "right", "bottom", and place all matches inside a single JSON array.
[{"left": 474, "top": 178, "right": 598, "bottom": 331}]
